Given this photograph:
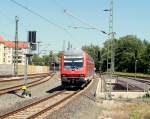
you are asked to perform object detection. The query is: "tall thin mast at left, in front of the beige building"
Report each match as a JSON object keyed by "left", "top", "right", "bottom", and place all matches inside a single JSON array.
[{"left": 14, "top": 16, "right": 19, "bottom": 76}]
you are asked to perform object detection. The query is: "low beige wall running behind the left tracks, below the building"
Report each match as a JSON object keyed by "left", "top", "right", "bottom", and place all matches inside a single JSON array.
[{"left": 0, "top": 64, "right": 49, "bottom": 75}]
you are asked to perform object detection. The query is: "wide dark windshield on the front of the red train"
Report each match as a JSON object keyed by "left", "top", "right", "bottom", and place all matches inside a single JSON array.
[{"left": 64, "top": 59, "right": 83, "bottom": 70}]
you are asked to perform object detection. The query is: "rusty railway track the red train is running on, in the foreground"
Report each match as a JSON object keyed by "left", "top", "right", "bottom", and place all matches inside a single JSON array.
[{"left": 0, "top": 72, "right": 97, "bottom": 119}]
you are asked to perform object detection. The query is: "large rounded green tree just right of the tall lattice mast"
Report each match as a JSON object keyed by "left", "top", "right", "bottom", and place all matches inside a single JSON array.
[{"left": 115, "top": 35, "right": 144, "bottom": 72}]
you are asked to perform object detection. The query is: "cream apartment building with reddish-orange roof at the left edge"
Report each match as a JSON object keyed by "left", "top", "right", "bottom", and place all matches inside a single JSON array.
[{"left": 0, "top": 36, "right": 27, "bottom": 65}]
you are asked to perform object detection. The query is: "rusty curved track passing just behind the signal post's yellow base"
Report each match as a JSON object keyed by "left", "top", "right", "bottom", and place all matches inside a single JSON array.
[{"left": 0, "top": 74, "right": 54, "bottom": 95}]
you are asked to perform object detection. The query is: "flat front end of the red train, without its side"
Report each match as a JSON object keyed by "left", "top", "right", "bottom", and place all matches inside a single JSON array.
[{"left": 61, "top": 50, "right": 85, "bottom": 87}]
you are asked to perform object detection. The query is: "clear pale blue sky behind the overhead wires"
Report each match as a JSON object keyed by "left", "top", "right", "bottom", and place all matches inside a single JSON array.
[{"left": 0, "top": 0, "right": 150, "bottom": 53}]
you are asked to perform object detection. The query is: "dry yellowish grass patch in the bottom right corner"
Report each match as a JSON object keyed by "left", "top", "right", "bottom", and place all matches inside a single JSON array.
[{"left": 101, "top": 101, "right": 150, "bottom": 119}]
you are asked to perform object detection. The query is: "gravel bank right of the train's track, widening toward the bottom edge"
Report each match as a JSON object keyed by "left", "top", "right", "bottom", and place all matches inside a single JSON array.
[{"left": 46, "top": 74, "right": 100, "bottom": 119}]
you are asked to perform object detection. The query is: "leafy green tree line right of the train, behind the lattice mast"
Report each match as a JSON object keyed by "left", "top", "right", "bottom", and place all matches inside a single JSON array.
[{"left": 82, "top": 35, "right": 150, "bottom": 74}]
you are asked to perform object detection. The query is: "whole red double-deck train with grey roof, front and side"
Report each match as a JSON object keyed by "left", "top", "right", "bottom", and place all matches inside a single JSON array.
[{"left": 60, "top": 50, "right": 94, "bottom": 87}]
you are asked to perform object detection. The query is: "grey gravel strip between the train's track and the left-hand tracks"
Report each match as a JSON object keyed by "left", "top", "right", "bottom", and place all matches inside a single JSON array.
[{"left": 0, "top": 74, "right": 61, "bottom": 115}]
